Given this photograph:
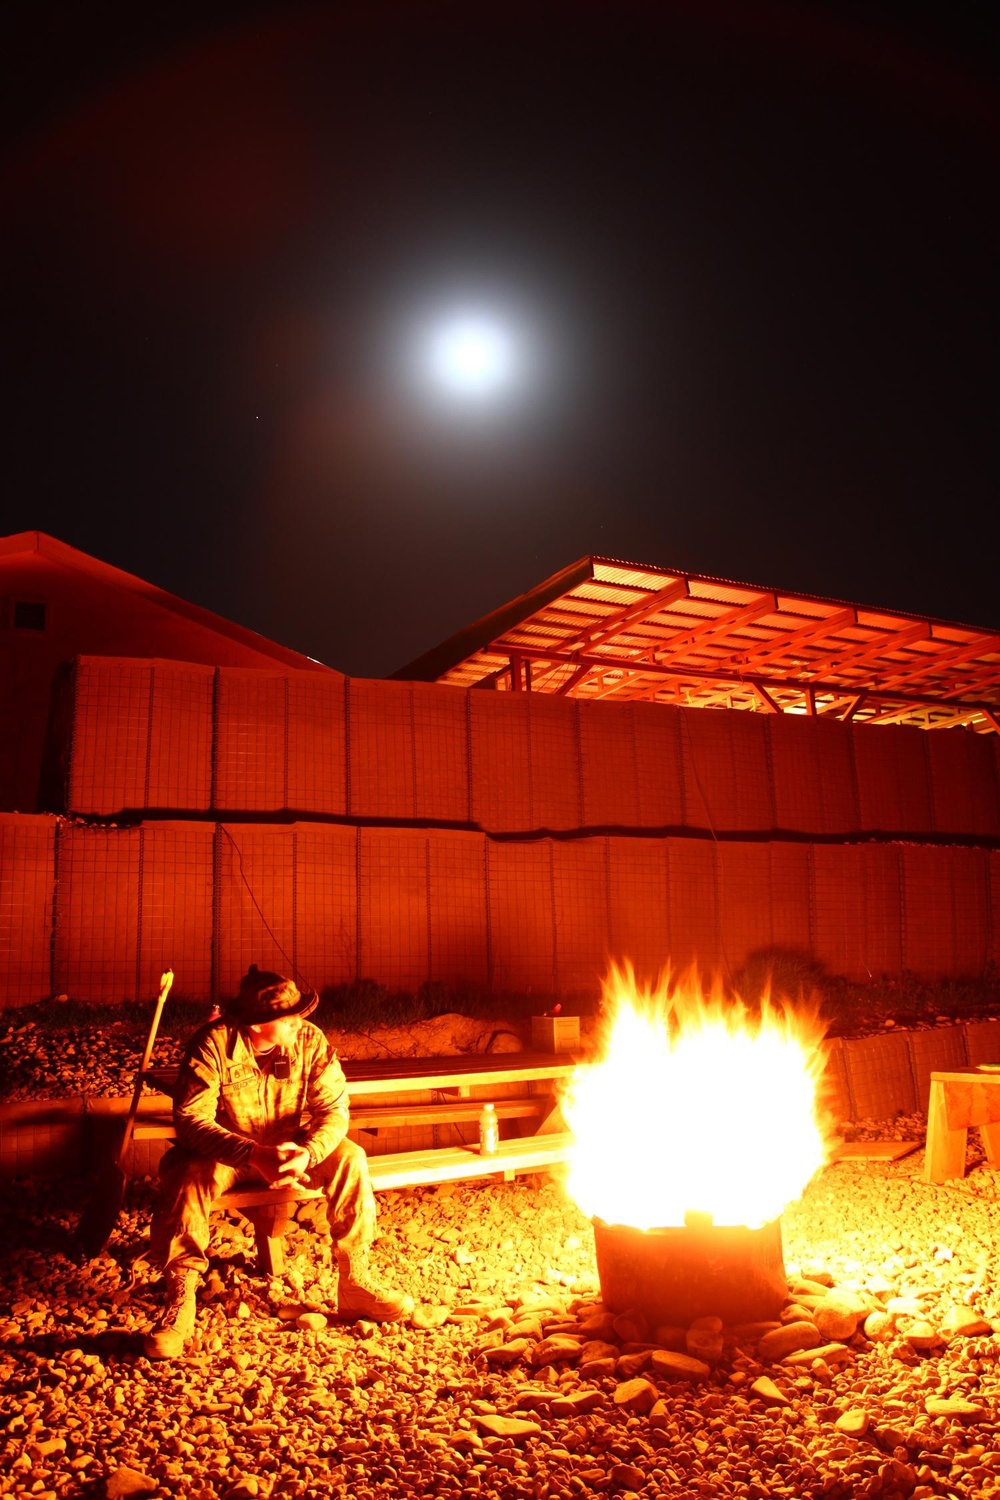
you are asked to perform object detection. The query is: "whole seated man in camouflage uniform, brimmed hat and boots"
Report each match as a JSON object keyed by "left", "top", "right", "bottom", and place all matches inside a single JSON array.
[{"left": 145, "top": 965, "right": 414, "bottom": 1359}]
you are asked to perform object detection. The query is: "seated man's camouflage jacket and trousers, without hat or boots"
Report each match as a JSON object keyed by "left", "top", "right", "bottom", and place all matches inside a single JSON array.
[{"left": 150, "top": 1019, "right": 375, "bottom": 1272}]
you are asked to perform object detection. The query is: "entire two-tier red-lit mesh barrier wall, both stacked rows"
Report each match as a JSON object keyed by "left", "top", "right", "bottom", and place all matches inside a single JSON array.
[{"left": 0, "top": 657, "right": 1000, "bottom": 1008}]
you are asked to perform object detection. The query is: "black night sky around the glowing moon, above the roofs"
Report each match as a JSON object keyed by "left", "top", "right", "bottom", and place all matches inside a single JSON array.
[{"left": 0, "top": 0, "right": 1000, "bottom": 675}]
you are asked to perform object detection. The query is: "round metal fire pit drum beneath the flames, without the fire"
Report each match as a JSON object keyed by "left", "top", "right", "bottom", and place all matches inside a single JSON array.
[{"left": 594, "top": 1218, "right": 787, "bottom": 1328}]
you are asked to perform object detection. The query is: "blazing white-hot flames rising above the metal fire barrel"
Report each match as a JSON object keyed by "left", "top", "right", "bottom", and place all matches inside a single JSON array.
[{"left": 562, "top": 965, "right": 826, "bottom": 1229}]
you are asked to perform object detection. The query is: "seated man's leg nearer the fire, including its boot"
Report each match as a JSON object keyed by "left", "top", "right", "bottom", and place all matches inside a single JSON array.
[{"left": 309, "top": 1137, "right": 414, "bottom": 1323}]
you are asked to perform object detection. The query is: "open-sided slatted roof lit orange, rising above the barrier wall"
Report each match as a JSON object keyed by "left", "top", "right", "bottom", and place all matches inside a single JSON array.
[{"left": 393, "top": 557, "right": 1000, "bottom": 734}]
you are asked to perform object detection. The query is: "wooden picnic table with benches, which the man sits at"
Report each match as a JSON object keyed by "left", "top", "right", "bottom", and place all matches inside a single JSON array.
[{"left": 135, "top": 1053, "right": 579, "bottom": 1275}]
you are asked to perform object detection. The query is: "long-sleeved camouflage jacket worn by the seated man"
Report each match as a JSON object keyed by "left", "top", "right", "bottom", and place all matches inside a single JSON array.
[{"left": 174, "top": 1019, "right": 351, "bottom": 1167}]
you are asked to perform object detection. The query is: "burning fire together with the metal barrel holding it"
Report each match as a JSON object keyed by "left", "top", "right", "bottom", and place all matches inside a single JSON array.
[{"left": 564, "top": 968, "right": 826, "bottom": 1328}]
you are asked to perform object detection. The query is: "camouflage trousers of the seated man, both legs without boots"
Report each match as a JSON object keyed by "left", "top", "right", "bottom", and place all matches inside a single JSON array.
[{"left": 148, "top": 1136, "right": 376, "bottom": 1272}]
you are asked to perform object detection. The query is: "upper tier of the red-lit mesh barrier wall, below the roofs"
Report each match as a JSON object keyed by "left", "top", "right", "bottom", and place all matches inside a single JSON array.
[{"left": 66, "top": 657, "right": 1000, "bottom": 843}]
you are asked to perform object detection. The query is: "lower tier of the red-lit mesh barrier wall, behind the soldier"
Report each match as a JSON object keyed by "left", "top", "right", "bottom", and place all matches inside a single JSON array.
[{"left": 0, "top": 815, "right": 1000, "bottom": 1005}]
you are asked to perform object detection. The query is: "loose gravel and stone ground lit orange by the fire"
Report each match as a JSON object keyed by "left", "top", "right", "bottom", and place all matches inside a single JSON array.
[{"left": 0, "top": 1154, "right": 1000, "bottom": 1500}]
